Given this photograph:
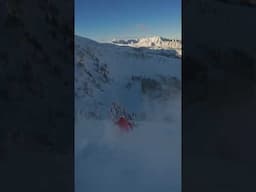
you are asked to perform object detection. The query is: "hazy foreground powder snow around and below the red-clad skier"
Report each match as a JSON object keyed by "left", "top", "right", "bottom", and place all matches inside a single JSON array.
[{"left": 75, "top": 91, "right": 181, "bottom": 192}]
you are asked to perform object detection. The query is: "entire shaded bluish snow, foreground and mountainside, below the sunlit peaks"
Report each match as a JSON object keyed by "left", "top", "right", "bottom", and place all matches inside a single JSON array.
[{"left": 75, "top": 36, "right": 181, "bottom": 192}]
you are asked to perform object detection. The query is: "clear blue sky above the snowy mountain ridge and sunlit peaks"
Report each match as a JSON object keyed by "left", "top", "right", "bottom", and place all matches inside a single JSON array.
[{"left": 75, "top": 0, "right": 181, "bottom": 41}]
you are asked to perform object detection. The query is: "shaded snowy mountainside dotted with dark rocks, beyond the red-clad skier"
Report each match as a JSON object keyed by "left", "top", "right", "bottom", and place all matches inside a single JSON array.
[{"left": 75, "top": 36, "right": 181, "bottom": 118}]
